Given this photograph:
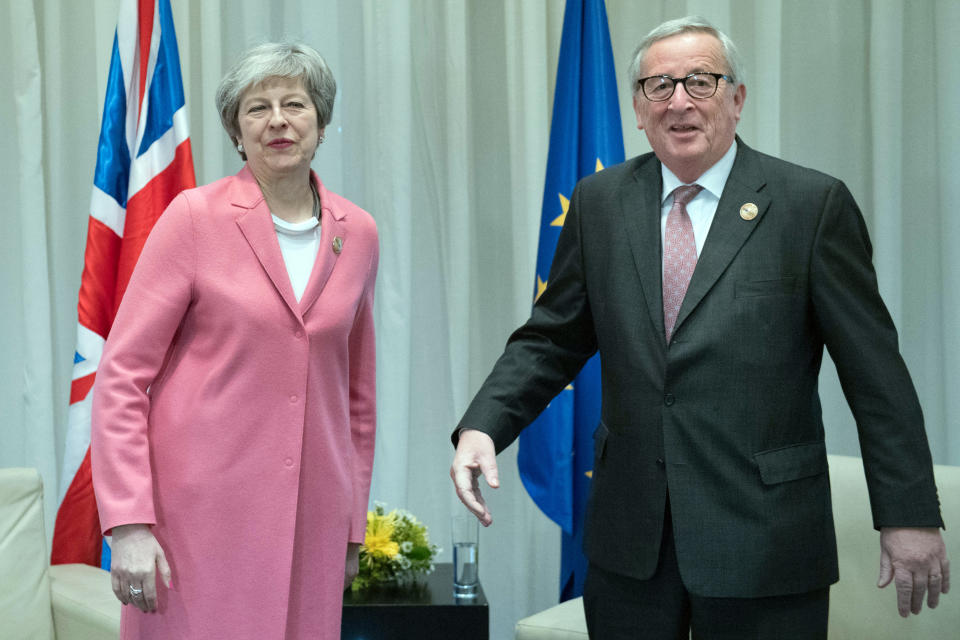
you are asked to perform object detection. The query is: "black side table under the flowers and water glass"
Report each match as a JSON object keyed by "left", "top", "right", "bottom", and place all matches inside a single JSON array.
[{"left": 340, "top": 563, "right": 490, "bottom": 640}]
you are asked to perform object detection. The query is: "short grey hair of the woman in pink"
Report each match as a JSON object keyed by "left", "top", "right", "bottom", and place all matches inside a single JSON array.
[{"left": 217, "top": 42, "right": 337, "bottom": 149}]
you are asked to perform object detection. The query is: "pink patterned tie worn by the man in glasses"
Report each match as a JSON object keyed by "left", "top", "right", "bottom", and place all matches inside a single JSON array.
[{"left": 663, "top": 184, "right": 703, "bottom": 344}]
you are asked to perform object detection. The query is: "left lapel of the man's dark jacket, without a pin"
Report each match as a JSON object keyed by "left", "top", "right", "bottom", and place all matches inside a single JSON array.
[{"left": 620, "top": 154, "right": 666, "bottom": 343}]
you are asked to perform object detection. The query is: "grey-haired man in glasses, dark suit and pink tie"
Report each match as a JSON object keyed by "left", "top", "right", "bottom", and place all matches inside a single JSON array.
[{"left": 450, "top": 18, "right": 949, "bottom": 640}]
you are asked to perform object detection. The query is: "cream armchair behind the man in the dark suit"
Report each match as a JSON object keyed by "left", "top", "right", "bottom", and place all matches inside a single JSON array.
[{"left": 515, "top": 455, "right": 960, "bottom": 640}]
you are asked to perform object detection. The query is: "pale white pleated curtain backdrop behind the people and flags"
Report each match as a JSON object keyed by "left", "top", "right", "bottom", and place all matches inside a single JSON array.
[{"left": 0, "top": 0, "right": 960, "bottom": 639}]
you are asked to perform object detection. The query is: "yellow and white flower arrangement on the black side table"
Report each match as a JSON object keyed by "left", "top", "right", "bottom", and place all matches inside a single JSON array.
[{"left": 351, "top": 502, "right": 440, "bottom": 591}]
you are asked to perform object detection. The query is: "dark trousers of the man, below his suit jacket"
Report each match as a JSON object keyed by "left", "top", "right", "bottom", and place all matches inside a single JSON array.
[{"left": 583, "top": 507, "right": 830, "bottom": 640}]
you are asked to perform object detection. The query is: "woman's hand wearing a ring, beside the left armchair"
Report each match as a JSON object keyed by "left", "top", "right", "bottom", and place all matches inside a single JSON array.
[{"left": 110, "top": 524, "right": 172, "bottom": 612}]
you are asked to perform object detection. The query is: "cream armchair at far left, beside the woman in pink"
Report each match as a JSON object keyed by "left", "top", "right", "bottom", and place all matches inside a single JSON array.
[{"left": 0, "top": 469, "right": 121, "bottom": 640}]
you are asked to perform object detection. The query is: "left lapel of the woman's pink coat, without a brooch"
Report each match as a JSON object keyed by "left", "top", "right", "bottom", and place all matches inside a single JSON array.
[{"left": 230, "top": 166, "right": 300, "bottom": 318}]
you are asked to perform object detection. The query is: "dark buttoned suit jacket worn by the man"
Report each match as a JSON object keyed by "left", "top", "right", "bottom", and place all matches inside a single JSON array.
[{"left": 454, "top": 140, "right": 942, "bottom": 597}]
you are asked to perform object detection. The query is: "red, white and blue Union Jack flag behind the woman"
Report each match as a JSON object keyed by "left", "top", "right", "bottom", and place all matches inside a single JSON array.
[{"left": 50, "top": 0, "right": 196, "bottom": 568}]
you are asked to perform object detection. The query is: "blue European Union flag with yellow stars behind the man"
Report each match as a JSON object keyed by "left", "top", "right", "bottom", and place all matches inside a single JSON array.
[{"left": 517, "top": 0, "right": 624, "bottom": 601}]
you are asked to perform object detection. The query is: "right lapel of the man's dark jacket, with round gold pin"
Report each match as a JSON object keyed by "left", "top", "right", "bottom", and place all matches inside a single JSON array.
[{"left": 661, "top": 144, "right": 770, "bottom": 332}]
